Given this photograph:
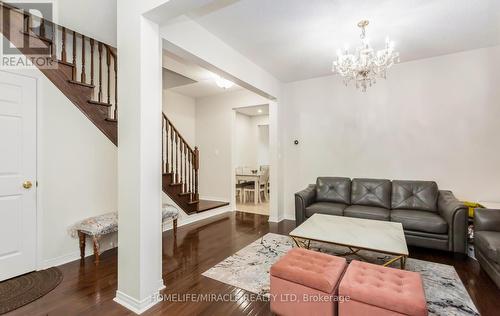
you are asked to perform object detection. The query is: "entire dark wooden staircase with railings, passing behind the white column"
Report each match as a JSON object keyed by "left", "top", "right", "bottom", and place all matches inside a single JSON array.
[{"left": 0, "top": 1, "right": 229, "bottom": 214}]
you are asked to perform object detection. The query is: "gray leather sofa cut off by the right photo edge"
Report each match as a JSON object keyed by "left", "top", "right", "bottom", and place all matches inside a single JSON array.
[{"left": 474, "top": 208, "right": 500, "bottom": 288}]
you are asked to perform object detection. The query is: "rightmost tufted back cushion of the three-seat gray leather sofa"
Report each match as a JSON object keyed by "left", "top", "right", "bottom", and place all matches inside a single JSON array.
[{"left": 391, "top": 180, "right": 439, "bottom": 212}]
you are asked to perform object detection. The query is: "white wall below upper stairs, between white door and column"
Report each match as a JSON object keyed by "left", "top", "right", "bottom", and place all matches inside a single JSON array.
[{"left": 38, "top": 75, "right": 117, "bottom": 265}]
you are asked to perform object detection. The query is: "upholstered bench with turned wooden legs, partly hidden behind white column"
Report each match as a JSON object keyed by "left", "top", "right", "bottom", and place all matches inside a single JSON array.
[{"left": 72, "top": 204, "right": 179, "bottom": 264}]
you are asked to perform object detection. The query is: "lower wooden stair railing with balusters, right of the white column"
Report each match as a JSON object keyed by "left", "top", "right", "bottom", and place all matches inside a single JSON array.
[{"left": 162, "top": 113, "right": 200, "bottom": 202}]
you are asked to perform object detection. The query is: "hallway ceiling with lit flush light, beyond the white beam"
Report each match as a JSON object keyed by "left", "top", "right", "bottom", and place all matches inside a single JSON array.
[{"left": 163, "top": 51, "right": 242, "bottom": 98}]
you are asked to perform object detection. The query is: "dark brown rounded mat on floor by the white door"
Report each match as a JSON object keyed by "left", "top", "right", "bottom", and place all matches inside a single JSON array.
[{"left": 0, "top": 268, "right": 63, "bottom": 315}]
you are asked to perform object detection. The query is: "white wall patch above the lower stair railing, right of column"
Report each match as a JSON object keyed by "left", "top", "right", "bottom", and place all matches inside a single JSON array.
[{"left": 163, "top": 90, "right": 196, "bottom": 143}]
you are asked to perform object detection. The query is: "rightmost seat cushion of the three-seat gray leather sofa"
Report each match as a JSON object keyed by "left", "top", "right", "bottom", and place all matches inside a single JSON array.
[{"left": 391, "top": 210, "right": 448, "bottom": 234}]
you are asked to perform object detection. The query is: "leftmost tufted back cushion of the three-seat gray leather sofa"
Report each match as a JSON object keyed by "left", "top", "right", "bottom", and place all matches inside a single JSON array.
[{"left": 316, "top": 177, "right": 351, "bottom": 204}]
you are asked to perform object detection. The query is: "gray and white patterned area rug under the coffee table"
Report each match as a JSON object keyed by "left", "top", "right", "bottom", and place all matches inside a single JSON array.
[{"left": 203, "top": 233, "right": 479, "bottom": 316}]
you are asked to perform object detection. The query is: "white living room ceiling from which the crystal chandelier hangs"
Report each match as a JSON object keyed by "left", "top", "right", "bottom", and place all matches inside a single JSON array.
[{"left": 189, "top": 0, "right": 500, "bottom": 82}]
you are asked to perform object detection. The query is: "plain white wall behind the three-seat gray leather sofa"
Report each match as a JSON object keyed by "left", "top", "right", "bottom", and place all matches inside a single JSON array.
[{"left": 284, "top": 46, "right": 500, "bottom": 218}]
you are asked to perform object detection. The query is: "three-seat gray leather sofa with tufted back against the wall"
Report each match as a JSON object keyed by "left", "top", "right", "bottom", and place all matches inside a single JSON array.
[{"left": 295, "top": 177, "right": 468, "bottom": 254}]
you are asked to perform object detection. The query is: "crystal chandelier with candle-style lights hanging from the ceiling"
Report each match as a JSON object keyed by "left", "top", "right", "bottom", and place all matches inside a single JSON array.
[{"left": 332, "top": 20, "right": 399, "bottom": 92}]
